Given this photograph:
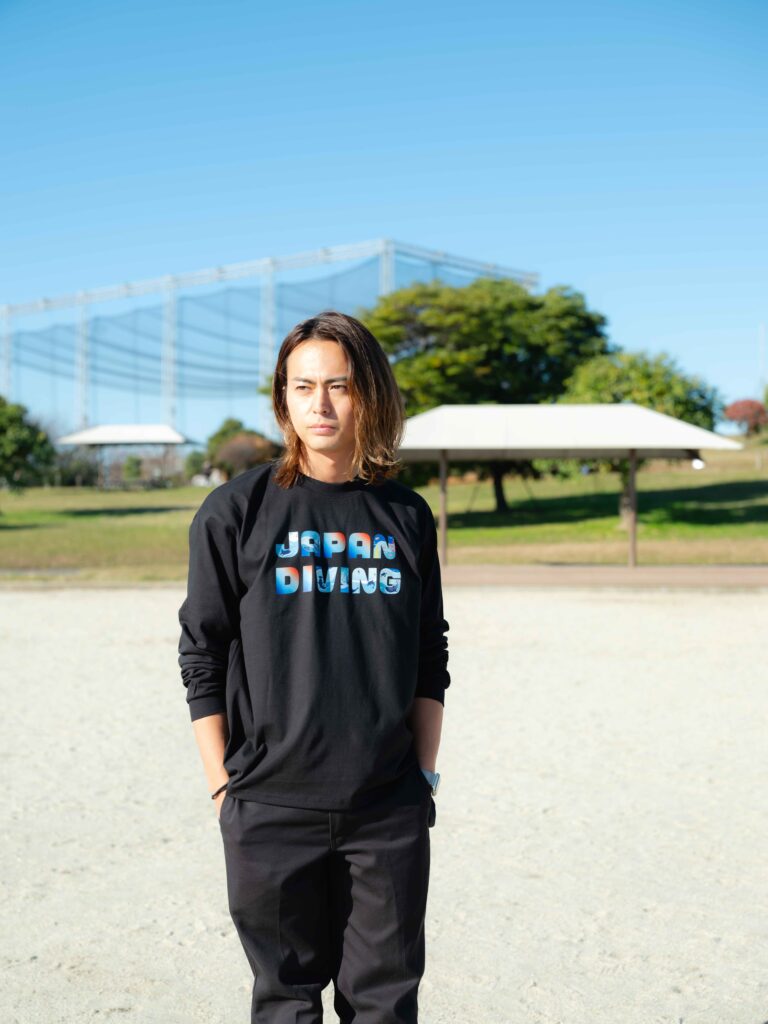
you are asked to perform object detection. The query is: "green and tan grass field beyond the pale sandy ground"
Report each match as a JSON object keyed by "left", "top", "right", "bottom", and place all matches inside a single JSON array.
[{"left": 0, "top": 445, "right": 768, "bottom": 583}]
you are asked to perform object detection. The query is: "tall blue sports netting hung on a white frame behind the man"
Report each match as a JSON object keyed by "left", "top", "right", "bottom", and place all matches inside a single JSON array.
[{"left": 2, "top": 242, "right": 535, "bottom": 441}]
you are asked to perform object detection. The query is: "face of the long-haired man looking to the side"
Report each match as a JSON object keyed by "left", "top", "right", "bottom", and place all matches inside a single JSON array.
[{"left": 286, "top": 338, "right": 354, "bottom": 466}]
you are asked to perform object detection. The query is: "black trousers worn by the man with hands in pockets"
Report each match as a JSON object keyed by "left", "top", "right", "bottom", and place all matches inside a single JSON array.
[{"left": 219, "top": 765, "right": 435, "bottom": 1024}]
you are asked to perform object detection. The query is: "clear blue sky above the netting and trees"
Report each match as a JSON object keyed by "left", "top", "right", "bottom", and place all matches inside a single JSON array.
[{"left": 0, "top": 0, "right": 768, "bottom": 419}]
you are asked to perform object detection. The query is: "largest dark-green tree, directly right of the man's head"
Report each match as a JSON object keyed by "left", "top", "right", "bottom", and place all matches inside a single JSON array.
[{"left": 358, "top": 278, "right": 612, "bottom": 511}]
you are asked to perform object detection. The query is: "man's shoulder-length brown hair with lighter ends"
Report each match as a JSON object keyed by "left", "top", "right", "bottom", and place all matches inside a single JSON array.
[{"left": 272, "top": 309, "right": 406, "bottom": 487}]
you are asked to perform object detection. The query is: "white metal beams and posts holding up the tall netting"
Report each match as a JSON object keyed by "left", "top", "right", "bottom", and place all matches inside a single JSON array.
[{"left": 0, "top": 239, "right": 539, "bottom": 427}]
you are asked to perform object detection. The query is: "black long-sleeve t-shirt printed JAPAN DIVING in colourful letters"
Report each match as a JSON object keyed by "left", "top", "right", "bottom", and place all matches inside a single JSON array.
[{"left": 178, "top": 463, "right": 451, "bottom": 810}]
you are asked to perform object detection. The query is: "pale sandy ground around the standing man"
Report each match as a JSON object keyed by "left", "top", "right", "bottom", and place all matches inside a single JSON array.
[{"left": 0, "top": 586, "right": 768, "bottom": 1024}]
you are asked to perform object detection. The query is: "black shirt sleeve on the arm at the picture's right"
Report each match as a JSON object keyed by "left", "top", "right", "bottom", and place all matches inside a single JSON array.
[{"left": 416, "top": 497, "right": 451, "bottom": 703}]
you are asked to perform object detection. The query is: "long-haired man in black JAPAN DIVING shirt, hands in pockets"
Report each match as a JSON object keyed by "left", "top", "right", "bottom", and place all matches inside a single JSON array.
[{"left": 179, "top": 311, "right": 450, "bottom": 1024}]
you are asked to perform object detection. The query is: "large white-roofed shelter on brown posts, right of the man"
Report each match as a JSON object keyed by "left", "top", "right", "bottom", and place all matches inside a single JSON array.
[{"left": 398, "top": 402, "right": 741, "bottom": 566}]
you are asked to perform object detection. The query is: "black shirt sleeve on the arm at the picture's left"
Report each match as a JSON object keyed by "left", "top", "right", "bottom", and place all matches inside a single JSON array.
[{"left": 178, "top": 502, "right": 240, "bottom": 722}]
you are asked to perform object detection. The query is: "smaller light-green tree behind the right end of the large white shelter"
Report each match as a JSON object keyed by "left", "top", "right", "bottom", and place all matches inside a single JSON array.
[{"left": 559, "top": 351, "right": 723, "bottom": 525}]
